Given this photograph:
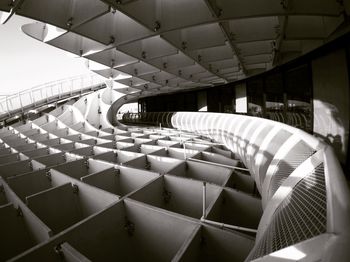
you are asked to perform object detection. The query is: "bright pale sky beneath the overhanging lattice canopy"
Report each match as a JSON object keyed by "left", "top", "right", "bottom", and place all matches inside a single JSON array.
[{"left": 0, "top": 16, "right": 91, "bottom": 95}]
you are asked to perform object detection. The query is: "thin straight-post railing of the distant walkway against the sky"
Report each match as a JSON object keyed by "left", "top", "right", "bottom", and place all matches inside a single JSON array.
[{"left": 0, "top": 74, "right": 105, "bottom": 120}]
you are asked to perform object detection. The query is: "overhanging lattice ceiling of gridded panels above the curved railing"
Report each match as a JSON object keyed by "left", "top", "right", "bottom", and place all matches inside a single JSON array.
[{"left": 0, "top": 0, "right": 346, "bottom": 94}]
